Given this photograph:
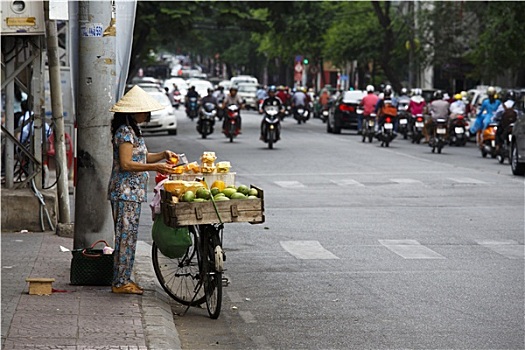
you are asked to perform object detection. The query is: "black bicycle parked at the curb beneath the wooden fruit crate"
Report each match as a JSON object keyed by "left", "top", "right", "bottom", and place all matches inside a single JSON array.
[{"left": 152, "top": 224, "right": 225, "bottom": 319}]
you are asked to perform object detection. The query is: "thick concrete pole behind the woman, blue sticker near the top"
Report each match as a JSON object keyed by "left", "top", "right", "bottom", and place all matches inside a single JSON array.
[{"left": 73, "top": 0, "right": 116, "bottom": 249}]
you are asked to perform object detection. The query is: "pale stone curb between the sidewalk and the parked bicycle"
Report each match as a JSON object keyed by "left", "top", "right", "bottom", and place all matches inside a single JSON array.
[{"left": 134, "top": 241, "right": 182, "bottom": 350}]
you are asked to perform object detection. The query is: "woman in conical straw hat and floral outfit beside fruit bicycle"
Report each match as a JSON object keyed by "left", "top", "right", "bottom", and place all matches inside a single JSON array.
[{"left": 108, "top": 86, "right": 178, "bottom": 294}]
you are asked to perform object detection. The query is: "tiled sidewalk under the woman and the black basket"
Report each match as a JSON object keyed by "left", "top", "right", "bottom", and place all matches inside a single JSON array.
[{"left": 1, "top": 231, "right": 181, "bottom": 350}]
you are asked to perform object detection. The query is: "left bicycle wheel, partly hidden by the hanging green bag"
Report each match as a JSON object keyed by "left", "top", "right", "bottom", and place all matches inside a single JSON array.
[{"left": 151, "top": 226, "right": 205, "bottom": 306}]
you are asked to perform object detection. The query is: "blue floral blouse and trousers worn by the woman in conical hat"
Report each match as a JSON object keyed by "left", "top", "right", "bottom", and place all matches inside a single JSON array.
[{"left": 108, "top": 125, "right": 149, "bottom": 287}]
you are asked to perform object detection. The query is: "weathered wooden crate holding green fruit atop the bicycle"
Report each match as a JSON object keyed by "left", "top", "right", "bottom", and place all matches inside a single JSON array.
[{"left": 161, "top": 185, "right": 264, "bottom": 227}]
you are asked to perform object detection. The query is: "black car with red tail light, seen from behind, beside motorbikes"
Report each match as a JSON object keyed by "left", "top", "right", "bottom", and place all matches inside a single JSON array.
[{"left": 326, "top": 90, "right": 366, "bottom": 134}]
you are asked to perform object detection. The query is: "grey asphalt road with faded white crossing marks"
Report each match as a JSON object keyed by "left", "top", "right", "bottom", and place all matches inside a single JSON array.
[{"left": 141, "top": 112, "right": 525, "bottom": 349}]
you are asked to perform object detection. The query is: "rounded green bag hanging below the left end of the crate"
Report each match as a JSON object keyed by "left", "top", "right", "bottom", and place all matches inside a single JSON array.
[{"left": 151, "top": 215, "right": 193, "bottom": 259}]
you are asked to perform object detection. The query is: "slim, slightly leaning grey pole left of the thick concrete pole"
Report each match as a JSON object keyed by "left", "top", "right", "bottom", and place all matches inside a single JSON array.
[{"left": 44, "top": 1, "right": 71, "bottom": 224}]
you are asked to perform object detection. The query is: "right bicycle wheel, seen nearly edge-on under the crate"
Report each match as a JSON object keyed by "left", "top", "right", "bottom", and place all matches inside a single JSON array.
[{"left": 202, "top": 226, "right": 223, "bottom": 319}]
